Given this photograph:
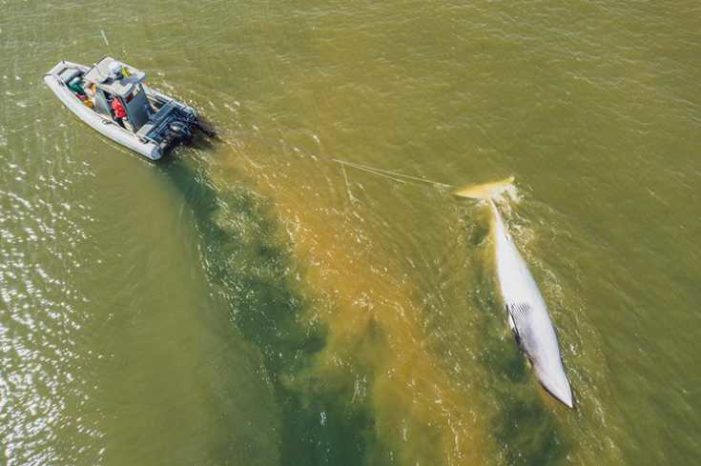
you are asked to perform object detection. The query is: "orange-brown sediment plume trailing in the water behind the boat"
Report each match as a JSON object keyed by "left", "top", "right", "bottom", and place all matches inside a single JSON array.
[{"left": 213, "top": 144, "right": 494, "bottom": 465}]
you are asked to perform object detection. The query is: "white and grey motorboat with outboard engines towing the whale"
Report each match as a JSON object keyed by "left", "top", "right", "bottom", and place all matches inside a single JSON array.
[{"left": 44, "top": 57, "right": 212, "bottom": 160}]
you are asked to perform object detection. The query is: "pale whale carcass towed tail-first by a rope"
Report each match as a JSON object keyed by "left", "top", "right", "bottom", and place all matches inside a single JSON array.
[{"left": 455, "top": 177, "right": 574, "bottom": 408}]
